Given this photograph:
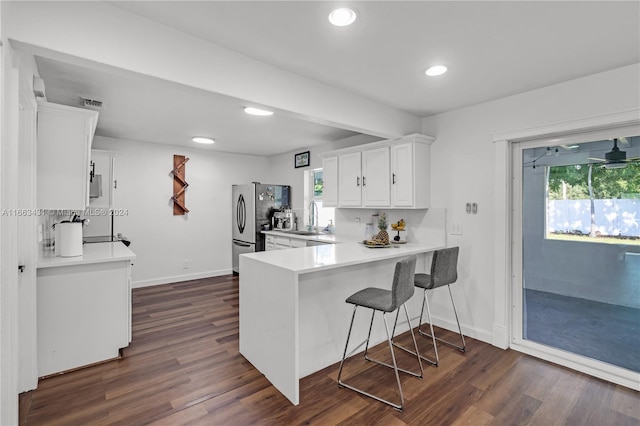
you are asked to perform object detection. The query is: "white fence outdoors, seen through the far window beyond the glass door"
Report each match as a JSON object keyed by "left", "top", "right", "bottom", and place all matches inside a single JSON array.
[{"left": 547, "top": 199, "right": 640, "bottom": 237}]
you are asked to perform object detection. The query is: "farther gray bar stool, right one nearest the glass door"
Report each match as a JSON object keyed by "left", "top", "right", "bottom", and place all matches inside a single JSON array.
[{"left": 412, "top": 247, "right": 466, "bottom": 366}]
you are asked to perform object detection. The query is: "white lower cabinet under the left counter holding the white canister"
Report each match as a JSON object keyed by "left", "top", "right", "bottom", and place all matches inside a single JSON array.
[{"left": 37, "top": 260, "right": 131, "bottom": 377}]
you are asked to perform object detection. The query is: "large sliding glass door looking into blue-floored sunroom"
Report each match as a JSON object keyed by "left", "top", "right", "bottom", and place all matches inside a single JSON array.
[{"left": 513, "top": 131, "right": 640, "bottom": 375}]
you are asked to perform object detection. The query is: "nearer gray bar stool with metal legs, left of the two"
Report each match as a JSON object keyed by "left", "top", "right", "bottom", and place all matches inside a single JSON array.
[{"left": 338, "top": 256, "right": 423, "bottom": 411}]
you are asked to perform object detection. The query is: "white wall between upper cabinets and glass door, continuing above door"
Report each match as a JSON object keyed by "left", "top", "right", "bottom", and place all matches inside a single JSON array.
[{"left": 422, "top": 64, "right": 640, "bottom": 346}]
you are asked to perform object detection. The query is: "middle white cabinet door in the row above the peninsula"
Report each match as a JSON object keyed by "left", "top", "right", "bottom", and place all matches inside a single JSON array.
[{"left": 362, "top": 146, "right": 391, "bottom": 207}]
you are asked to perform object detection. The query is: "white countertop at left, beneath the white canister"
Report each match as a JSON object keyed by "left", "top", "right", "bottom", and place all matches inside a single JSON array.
[{"left": 37, "top": 241, "right": 136, "bottom": 268}]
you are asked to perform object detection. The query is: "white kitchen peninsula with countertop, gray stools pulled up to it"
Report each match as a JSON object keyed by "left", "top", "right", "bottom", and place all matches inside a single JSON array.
[{"left": 240, "top": 238, "right": 444, "bottom": 405}]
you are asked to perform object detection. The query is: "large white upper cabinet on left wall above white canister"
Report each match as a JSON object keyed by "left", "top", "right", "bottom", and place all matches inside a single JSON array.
[{"left": 36, "top": 102, "right": 98, "bottom": 210}]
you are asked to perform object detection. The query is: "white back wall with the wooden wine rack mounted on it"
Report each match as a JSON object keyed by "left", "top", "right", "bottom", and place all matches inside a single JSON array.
[{"left": 93, "top": 136, "right": 270, "bottom": 287}]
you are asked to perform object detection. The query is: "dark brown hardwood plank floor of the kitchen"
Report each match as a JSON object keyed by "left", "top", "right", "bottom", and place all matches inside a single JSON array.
[{"left": 20, "top": 276, "right": 640, "bottom": 426}]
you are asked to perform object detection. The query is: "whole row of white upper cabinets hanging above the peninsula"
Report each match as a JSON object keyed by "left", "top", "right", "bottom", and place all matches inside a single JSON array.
[{"left": 323, "top": 134, "right": 434, "bottom": 209}]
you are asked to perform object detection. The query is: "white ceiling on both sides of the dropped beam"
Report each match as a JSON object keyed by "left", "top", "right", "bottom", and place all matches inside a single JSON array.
[{"left": 37, "top": 1, "right": 640, "bottom": 155}]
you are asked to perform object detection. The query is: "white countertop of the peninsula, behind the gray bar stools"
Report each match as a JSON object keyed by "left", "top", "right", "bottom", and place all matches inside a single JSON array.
[{"left": 240, "top": 242, "right": 444, "bottom": 274}]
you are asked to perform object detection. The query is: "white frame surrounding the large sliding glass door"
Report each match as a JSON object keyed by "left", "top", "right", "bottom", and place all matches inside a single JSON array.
[{"left": 492, "top": 108, "right": 640, "bottom": 390}]
